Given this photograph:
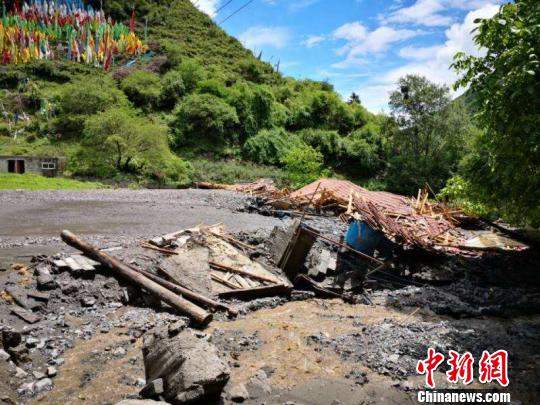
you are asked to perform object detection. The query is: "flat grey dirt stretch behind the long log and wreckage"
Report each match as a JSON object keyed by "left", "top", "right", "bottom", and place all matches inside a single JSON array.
[{"left": 0, "top": 189, "right": 281, "bottom": 266}]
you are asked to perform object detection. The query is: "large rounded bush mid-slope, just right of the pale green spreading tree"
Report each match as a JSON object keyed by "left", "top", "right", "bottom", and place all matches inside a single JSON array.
[{"left": 171, "top": 94, "right": 238, "bottom": 146}]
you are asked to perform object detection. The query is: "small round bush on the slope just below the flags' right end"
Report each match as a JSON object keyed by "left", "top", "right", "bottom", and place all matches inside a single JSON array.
[{"left": 120, "top": 70, "right": 161, "bottom": 109}]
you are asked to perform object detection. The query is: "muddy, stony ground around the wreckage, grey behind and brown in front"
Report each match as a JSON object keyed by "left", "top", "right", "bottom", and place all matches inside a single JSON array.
[{"left": 0, "top": 190, "right": 540, "bottom": 405}]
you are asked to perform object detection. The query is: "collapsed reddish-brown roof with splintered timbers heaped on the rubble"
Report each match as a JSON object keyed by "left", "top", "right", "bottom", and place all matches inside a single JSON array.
[{"left": 202, "top": 179, "right": 528, "bottom": 257}]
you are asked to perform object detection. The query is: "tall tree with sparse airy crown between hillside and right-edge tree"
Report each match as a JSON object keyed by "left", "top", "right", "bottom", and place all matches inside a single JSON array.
[{"left": 388, "top": 75, "right": 470, "bottom": 194}]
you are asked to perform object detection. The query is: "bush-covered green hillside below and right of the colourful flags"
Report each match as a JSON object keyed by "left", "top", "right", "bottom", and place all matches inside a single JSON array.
[{"left": 0, "top": 0, "right": 383, "bottom": 186}]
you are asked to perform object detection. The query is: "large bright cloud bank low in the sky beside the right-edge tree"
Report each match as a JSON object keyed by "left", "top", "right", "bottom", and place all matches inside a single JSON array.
[{"left": 357, "top": 4, "right": 499, "bottom": 111}]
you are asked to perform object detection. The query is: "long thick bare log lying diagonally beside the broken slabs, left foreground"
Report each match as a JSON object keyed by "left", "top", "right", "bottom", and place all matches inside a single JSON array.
[{"left": 61, "top": 231, "right": 212, "bottom": 325}]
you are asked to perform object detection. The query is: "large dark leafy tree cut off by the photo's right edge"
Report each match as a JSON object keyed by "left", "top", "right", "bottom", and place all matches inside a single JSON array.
[{"left": 453, "top": 0, "right": 540, "bottom": 226}]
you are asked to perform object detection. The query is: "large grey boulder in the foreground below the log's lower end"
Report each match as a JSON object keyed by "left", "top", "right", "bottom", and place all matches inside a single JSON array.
[{"left": 143, "top": 328, "right": 230, "bottom": 404}]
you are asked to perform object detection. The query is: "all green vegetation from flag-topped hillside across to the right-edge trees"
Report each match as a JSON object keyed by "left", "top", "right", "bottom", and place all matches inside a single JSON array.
[{"left": 0, "top": 0, "right": 539, "bottom": 224}]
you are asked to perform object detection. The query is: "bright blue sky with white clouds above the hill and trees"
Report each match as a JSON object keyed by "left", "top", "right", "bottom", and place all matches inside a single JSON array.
[{"left": 192, "top": 0, "right": 501, "bottom": 112}]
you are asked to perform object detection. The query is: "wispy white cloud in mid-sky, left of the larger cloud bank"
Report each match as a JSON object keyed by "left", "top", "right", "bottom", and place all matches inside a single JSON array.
[{"left": 333, "top": 21, "right": 423, "bottom": 68}]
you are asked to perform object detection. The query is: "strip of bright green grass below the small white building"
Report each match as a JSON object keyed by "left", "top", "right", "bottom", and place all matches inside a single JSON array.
[{"left": 0, "top": 173, "right": 104, "bottom": 190}]
